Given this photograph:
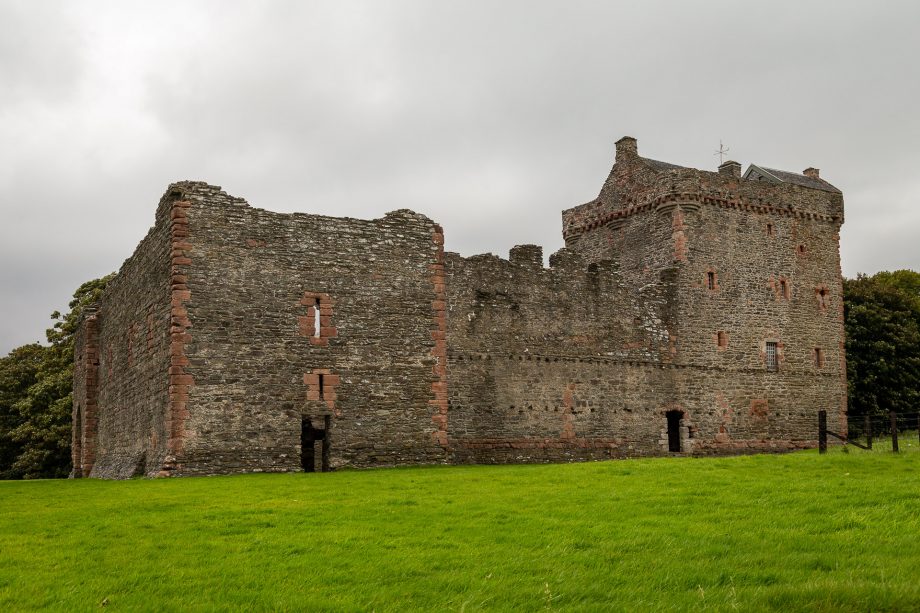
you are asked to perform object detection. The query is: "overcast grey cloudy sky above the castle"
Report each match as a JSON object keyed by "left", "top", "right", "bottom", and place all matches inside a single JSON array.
[{"left": 0, "top": 0, "right": 920, "bottom": 354}]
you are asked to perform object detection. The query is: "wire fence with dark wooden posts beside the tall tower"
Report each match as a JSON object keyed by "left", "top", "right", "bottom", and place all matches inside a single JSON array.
[{"left": 818, "top": 411, "right": 920, "bottom": 453}]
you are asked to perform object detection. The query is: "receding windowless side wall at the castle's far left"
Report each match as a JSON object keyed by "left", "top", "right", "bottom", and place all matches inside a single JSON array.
[{"left": 82, "top": 189, "right": 178, "bottom": 478}]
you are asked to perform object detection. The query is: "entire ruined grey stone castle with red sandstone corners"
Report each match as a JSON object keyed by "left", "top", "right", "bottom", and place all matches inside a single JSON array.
[{"left": 73, "top": 137, "right": 846, "bottom": 478}]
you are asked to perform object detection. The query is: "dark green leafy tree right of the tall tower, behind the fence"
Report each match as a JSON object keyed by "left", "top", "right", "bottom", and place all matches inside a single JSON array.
[{"left": 844, "top": 270, "right": 920, "bottom": 415}]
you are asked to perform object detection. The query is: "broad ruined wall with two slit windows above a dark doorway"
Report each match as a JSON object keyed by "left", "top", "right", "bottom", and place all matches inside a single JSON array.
[{"left": 173, "top": 187, "right": 446, "bottom": 474}]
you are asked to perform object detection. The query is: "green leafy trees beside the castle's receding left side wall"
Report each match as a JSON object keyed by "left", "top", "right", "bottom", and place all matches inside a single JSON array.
[{"left": 0, "top": 275, "right": 112, "bottom": 479}]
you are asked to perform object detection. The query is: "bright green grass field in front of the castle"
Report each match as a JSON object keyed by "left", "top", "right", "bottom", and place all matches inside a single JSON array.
[{"left": 0, "top": 441, "right": 920, "bottom": 611}]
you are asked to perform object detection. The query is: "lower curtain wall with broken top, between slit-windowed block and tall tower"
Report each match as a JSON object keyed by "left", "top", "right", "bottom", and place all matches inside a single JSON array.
[{"left": 446, "top": 246, "right": 673, "bottom": 462}]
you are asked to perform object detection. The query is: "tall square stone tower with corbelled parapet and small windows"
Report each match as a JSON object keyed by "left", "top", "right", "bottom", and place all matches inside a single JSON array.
[{"left": 563, "top": 141, "right": 846, "bottom": 453}]
